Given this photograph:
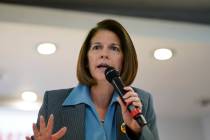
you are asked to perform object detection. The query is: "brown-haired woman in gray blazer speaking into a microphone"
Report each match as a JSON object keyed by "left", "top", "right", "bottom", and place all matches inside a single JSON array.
[{"left": 26, "top": 19, "right": 159, "bottom": 140}]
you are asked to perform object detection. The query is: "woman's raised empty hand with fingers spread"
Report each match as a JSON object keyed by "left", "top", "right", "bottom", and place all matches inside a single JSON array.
[{"left": 26, "top": 115, "right": 67, "bottom": 140}]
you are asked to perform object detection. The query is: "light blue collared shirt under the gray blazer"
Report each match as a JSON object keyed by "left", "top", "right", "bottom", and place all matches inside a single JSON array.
[{"left": 63, "top": 84, "right": 118, "bottom": 140}]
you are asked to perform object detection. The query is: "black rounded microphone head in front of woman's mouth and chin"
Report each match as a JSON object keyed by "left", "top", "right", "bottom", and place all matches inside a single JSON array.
[{"left": 104, "top": 66, "right": 120, "bottom": 83}]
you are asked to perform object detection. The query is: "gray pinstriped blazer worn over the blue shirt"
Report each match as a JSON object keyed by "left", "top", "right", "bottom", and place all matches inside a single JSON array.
[{"left": 37, "top": 88, "right": 159, "bottom": 140}]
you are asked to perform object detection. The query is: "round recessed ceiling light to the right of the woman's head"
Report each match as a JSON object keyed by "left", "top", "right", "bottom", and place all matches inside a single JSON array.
[{"left": 154, "top": 48, "right": 173, "bottom": 60}]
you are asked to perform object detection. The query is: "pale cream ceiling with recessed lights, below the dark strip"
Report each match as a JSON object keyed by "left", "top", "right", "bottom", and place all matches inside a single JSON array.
[{"left": 0, "top": 1, "right": 210, "bottom": 118}]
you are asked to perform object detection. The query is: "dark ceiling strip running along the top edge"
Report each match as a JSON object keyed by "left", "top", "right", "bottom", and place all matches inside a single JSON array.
[{"left": 0, "top": 0, "right": 210, "bottom": 24}]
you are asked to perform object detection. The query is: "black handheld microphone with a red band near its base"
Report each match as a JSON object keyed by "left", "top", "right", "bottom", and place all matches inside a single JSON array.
[{"left": 104, "top": 66, "right": 147, "bottom": 127}]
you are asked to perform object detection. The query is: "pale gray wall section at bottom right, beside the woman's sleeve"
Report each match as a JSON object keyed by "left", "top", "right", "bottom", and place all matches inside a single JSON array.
[{"left": 158, "top": 119, "right": 204, "bottom": 140}]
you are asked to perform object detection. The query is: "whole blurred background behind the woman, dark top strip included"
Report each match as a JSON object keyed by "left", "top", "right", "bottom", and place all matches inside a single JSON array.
[{"left": 0, "top": 0, "right": 210, "bottom": 140}]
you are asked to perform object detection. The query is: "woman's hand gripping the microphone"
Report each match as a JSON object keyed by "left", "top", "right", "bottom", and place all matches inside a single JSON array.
[{"left": 118, "top": 87, "right": 142, "bottom": 134}]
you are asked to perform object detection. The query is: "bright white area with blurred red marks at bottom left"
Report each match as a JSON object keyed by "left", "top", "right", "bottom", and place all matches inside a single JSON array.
[{"left": 0, "top": 107, "right": 38, "bottom": 140}]
